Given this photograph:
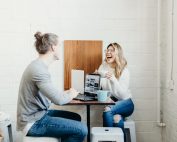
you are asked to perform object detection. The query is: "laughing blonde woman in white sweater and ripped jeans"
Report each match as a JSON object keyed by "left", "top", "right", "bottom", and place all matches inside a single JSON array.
[{"left": 98, "top": 43, "right": 134, "bottom": 139}]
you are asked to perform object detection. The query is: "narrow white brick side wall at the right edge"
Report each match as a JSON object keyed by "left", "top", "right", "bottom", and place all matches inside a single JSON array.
[{"left": 161, "top": 0, "right": 177, "bottom": 142}]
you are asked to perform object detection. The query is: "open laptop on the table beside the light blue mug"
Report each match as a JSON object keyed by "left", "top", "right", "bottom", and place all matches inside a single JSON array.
[{"left": 74, "top": 74, "right": 100, "bottom": 101}]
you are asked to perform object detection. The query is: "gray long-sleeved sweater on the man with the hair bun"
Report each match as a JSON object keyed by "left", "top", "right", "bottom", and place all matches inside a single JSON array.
[{"left": 17, "top": 59, "right": 72, "bottom": 131}]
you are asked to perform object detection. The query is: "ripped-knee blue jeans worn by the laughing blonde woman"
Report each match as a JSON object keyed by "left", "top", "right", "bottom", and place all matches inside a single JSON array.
[{"left": 103, "top": 99, "right": 134, "bottom": 131}]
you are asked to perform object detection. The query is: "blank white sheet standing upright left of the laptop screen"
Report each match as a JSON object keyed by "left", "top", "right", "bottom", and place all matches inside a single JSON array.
[{"left": 71, "top": 69, "right": 84, "bottom": 93}]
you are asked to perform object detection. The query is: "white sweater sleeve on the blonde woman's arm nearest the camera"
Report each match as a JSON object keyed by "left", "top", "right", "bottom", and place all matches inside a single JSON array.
[{"left": 110, "top": 68, "right": 129, "bottom": 98}]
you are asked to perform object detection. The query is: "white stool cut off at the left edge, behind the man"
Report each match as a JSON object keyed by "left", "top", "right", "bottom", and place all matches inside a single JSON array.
[{"left": 0, "top": 112, "right": 13, "bottom": 142}]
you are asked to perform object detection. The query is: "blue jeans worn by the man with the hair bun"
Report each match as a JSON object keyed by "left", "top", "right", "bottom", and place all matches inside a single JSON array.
[{"left": 27, "top": 110, "right": 88, "bottom": 142}]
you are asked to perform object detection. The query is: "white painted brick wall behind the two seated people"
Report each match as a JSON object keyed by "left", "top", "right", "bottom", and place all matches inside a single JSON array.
[{"left": 0, "top": 0, "right": 161, "bottom": 142}]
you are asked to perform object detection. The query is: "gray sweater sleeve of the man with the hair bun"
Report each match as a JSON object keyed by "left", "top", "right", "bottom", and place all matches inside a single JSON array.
[{"left": 33, "top": 71, "right": 73, "bottom": 105}]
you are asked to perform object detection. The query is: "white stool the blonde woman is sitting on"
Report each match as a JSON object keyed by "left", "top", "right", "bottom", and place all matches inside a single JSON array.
[{"left": 124, "top": 119, "right": 136, "bottom": 142}]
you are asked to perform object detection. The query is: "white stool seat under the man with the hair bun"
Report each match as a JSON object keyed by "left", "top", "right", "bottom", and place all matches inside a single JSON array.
[{"left": 23, "top": 136, "right": 60, "bottom": 142}]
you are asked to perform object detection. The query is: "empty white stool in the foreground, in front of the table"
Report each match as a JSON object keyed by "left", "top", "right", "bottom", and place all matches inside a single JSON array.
[{"left": 91, "top": 127, "right": 124, "bottom": 142}]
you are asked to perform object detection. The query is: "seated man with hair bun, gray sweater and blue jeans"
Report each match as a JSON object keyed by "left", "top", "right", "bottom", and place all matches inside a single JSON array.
[{"left": 17, "top": 32, "right": 87, "bottom": 142}]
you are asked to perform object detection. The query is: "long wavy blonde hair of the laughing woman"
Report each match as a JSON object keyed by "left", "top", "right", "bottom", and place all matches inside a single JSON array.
[{"left": 107, "top": 42, "right": 127, "bottom": 78}]
